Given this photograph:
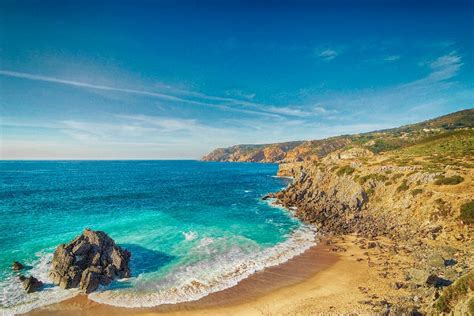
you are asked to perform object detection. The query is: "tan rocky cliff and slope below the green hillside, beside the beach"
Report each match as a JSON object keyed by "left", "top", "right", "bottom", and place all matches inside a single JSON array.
[{"left": 264, "top": 148, "right": 474, "bottom": 315}]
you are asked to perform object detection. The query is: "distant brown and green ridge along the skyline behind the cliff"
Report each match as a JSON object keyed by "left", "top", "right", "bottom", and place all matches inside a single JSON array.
[{"left": 202, "top": 109, "right": 474, "bottom": 162}]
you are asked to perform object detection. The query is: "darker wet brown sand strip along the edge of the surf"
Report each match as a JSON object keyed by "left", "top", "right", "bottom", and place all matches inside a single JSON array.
[{"left": 28, "top": 242, "right": 339, "bottom": 315}]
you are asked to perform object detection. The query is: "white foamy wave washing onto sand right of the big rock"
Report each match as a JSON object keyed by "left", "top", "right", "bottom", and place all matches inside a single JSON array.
[{"left": 89, "top": 226, "right": 315, "bottom": 307}]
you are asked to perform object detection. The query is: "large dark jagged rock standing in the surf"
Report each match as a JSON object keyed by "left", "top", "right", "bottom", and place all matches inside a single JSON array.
[{"left": 50, "top": 229, "right": 131, "bottom": 293}]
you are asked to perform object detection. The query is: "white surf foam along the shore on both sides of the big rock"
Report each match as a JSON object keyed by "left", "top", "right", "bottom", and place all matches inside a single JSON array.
[{"left": 0, "top": 210, "right": 316, "bottom": 315}]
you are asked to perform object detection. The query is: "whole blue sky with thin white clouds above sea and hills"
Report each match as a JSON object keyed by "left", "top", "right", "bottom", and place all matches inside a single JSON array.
[{"left": 0, "top": 0, "right": 474, "bottom": 159}]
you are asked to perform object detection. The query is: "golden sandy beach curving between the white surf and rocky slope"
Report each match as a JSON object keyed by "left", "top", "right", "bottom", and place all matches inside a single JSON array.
[{"left": 28, "top": 236, "right": 412, "bottom": 315}]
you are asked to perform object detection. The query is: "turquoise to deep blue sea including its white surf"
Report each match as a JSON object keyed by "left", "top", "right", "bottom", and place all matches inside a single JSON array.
[{"left": 0, "top": 161, "right": 314, "bottom": 312}]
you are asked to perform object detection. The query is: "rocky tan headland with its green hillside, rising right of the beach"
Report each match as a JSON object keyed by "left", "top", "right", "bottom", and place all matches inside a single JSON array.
[{"left": 205, "top": 109, "right": 474, "bottom": 315}]
